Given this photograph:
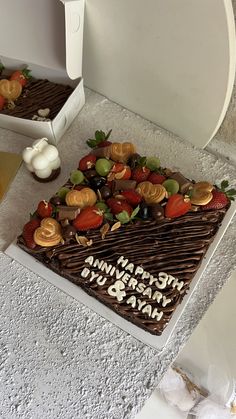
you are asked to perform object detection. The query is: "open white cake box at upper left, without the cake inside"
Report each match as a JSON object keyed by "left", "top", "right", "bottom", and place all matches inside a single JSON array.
[{"left": 0, "top": 0, "right": 85, "bottom": 144}]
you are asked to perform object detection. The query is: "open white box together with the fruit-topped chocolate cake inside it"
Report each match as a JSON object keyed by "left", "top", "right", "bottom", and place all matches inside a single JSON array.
[{"left": 0, "top": 0, "right": 85, "bottom": 144}]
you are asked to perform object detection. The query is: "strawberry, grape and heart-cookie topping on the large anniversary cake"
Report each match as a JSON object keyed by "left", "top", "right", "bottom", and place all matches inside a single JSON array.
[{"left": 22, "top": 131, "right": 236, "bottom": 249}]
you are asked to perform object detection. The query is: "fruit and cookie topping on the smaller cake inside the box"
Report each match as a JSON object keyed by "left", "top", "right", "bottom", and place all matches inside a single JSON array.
[{"left": 0, "top": 63, "right": 31, "bottom": 111}]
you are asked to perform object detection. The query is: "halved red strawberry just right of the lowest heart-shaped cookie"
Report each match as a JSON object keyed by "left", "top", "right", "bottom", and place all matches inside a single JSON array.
[{"left": 73, "top": 206, "right": 103, "bottom": 231}]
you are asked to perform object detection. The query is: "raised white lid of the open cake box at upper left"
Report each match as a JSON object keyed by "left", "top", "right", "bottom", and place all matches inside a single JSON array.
[{"left": 0, "top": 0, "right": 84, "bottom": 79}]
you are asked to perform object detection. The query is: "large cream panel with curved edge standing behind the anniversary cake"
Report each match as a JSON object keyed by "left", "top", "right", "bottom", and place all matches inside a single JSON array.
[{"left": 83, "top": 0, "right": 236, "bottom": 147}]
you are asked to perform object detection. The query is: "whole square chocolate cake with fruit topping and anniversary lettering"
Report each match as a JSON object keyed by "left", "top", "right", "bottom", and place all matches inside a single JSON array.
[{"left": 17, "top": 131, "right": 235, "bottom": 335}]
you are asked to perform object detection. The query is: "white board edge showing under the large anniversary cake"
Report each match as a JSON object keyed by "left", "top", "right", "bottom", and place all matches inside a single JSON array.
[{"left": 5, "top": 202, "right": 236, "bottom": 349}]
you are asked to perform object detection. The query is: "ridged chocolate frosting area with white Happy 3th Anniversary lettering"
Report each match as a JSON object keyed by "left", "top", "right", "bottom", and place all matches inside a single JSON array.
[{"left": 18, "top": 208, "right": 227, "bottom": 335}]
